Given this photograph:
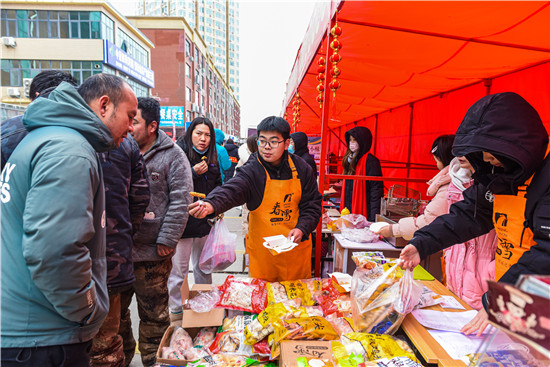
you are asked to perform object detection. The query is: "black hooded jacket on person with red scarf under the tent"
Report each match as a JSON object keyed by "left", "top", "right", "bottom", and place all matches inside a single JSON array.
[{"left": 342, "top": 126, "right": 384, "bottom": 222}]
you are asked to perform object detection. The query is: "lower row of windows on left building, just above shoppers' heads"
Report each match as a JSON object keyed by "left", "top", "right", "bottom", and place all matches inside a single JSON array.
[{"left": 0, "top": 60, "right": 103, "bottom": 87}]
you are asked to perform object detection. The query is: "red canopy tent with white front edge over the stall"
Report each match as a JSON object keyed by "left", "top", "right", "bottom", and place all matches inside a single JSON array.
[{"left": 283, "top": 0, "right": 550, "bottom": 274}]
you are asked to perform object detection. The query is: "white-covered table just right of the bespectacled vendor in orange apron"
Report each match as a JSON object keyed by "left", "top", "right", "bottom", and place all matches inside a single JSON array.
[{"left": 332, "top": 233, "right": 401, "bottom": 275}]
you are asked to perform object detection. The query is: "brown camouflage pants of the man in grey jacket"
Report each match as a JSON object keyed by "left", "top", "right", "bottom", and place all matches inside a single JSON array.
[{"left": 119, "top": 259, "right": 172, "bottom": 367}]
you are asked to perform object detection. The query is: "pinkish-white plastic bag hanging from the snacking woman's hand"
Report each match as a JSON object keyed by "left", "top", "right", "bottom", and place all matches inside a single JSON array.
[{"left": 199, "top": 219, "right": 237, "bottom": 274}]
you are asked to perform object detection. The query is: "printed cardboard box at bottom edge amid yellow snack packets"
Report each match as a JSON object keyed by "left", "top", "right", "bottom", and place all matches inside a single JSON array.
[{"left": 279, "top": 340, "right": 335, "bottom": 367}]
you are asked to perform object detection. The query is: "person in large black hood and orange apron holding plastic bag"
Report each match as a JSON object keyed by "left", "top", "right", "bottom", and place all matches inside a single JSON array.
[{"left": 401, "top": 92, "right": 550, "bottom": 334}]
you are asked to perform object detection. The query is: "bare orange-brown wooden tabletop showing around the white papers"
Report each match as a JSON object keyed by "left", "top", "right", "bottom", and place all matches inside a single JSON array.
[{"left": 401, "top": 280, "right": 472, "bottom": 367}]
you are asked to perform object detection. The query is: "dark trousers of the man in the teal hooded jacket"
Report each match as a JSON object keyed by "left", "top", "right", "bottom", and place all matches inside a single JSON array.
[{"left": 1, "top": 340, "right": 92, "bottom": 367}]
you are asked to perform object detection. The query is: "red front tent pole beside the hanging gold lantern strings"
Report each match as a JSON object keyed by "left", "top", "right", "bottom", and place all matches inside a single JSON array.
[{"left": 315, "top": 0, "right": 336, "bottom": 277}]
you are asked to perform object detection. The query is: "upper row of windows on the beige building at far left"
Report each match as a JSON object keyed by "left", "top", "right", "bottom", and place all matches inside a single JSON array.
[{"left": 0, "top": 9, "right": 101, "bottom": 39}]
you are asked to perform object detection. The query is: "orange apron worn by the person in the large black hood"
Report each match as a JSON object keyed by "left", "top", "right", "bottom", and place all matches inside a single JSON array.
[{"left": 493, "top": 176, "right": 537, "bottom": 281}]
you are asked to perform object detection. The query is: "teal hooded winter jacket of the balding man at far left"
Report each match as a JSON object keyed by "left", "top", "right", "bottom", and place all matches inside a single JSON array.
[{"left": 0, "top": 82, "right": 111, "bottom": 348}]
